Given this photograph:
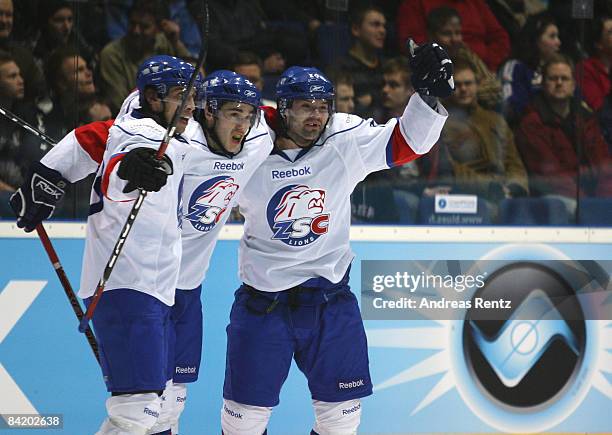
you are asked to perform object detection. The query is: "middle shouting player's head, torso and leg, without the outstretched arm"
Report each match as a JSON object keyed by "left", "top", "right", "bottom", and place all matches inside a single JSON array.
[{"left": 159, "top": 71, "right": 272, "bottom": 434}]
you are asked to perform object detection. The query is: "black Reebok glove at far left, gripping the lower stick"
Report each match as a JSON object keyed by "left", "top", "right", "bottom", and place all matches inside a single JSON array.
[{"left": 9, "top": 162, "right": 70, "bottom": 233}]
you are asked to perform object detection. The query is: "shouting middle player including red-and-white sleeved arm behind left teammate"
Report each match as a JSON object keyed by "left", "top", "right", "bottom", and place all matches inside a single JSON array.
[{"left": 8, "top": 66, "right": 272, "bottom": 435}]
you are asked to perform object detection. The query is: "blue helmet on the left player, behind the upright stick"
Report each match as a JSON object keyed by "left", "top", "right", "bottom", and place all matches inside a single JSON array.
[{"left": 136, "top": 55, "right": 201, "bottom": 101}]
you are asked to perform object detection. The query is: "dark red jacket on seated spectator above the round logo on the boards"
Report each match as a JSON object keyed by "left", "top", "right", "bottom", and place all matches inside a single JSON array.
[{"left": 515, "top": 96, "right": 612, "bottom": 198}]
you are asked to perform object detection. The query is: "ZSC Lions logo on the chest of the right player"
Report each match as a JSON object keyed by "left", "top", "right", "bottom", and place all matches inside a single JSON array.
[{"left": 267, "top": 184, "right": 329, "bottom": 246}]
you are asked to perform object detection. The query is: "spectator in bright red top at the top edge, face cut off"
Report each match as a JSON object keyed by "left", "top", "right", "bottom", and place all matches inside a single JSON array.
[{"left": 396, "top": 0, "right": 510, "bottom": 72}]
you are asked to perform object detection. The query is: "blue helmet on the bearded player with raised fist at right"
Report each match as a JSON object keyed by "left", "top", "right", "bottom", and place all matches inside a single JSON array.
[{"left": 276, "top": 66, "right": 335, "bottom": 111}]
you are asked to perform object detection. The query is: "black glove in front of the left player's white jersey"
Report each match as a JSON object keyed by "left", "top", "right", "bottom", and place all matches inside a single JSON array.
[{"left": 117, "top": 148, "right": 172, "bottom": 193}]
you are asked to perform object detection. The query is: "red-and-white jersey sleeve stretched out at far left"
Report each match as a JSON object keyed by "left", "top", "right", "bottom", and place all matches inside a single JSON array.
[{"left": 41, "top": 119, "right": 113, "bottom": 183}]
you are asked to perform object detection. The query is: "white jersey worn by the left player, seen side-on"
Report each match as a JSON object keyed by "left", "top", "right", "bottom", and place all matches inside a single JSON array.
[{"left": 79, "top": 118, "right": 192, "bottom": 305}]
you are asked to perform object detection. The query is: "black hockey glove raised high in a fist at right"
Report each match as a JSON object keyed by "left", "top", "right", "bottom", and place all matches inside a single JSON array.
[{"left": 407, "top": 39, "right": 455, "bottom": 98}]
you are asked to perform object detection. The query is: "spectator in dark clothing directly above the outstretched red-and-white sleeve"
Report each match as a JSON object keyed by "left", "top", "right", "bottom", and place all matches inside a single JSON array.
[{"left": 45, "top": 47, "right": 96, "bottom": 138}]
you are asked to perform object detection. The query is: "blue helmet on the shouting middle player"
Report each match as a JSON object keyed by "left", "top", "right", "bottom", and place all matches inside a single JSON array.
[{"left": 203, "top": 69, "right": 261, "bottom": 111}]
